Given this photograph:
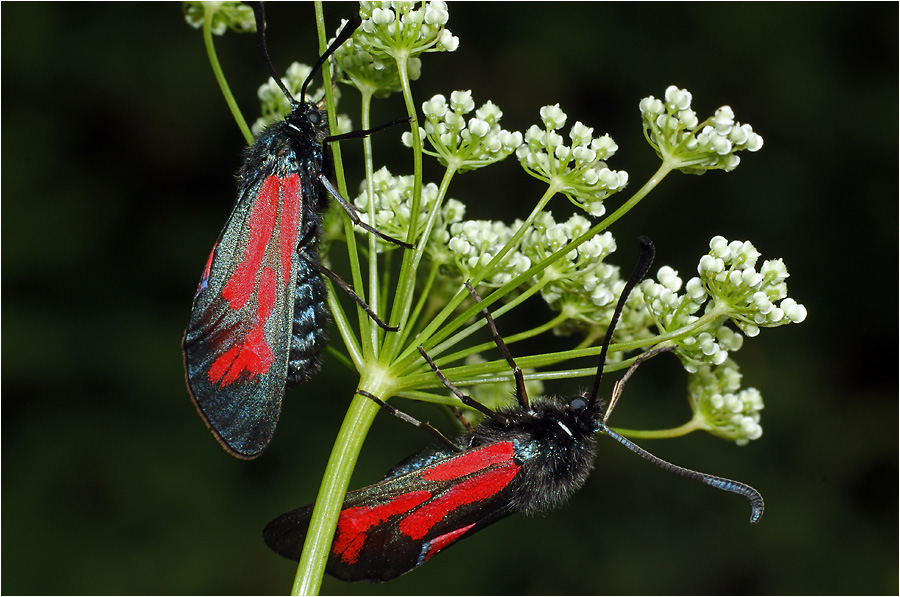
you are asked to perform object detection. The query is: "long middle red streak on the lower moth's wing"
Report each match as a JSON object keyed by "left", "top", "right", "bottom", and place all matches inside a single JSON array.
[{"left": 400, "top": 460, "right": 521, "bottom": 540}]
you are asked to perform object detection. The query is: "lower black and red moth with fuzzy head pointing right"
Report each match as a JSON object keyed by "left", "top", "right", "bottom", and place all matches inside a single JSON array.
[{"left": 263, "top": 238, "right": 764, "bottom": 581}]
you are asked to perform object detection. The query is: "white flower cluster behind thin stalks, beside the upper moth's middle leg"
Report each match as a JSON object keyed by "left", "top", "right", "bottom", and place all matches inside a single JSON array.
[{"left": 353, "top": 168, "right": 446, "bottom": 253}]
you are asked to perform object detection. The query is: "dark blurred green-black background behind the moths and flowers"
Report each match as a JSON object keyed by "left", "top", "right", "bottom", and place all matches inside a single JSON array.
[{"left": 2, "top": 3, "right": 898, "bottom": 595}]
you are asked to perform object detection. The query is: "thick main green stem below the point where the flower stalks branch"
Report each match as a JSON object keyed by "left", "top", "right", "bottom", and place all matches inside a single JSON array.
[{"left": 291, "top": 395, "right": 380, "bottom": 595}]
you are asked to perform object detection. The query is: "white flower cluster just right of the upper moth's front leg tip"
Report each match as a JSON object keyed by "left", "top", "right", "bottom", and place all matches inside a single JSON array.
[{"left": 403, "top": 91, "right": 522, "bottom": 172}]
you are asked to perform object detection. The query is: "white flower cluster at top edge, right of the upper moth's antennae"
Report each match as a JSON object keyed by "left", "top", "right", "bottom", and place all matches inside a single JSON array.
[{"left": 355, "top": 0, "right": 459, "bottom": 58}]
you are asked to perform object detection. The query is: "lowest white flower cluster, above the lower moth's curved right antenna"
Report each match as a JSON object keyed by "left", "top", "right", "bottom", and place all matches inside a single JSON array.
[{"left": 688, "top": 359, "right": 763, "bottom": 446}]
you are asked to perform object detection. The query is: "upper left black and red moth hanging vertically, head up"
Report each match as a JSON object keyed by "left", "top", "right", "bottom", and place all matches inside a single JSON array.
[{"left": 182, "top": 2, "right": 409, "bottom": 459}]
